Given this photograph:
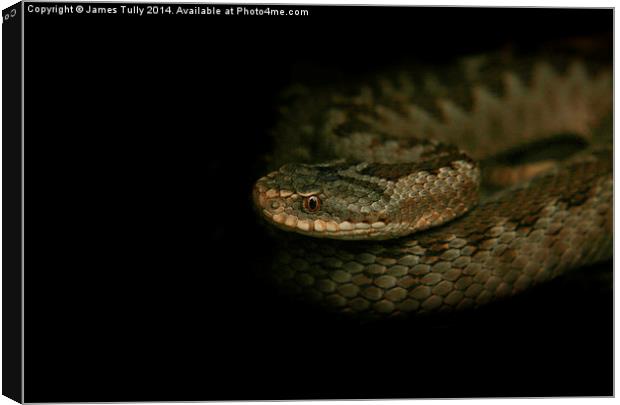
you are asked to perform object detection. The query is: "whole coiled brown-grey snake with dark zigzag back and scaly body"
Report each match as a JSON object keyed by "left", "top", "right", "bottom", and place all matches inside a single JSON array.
[{"left": 253, "top": 52, "right": 613, "bottom": 318}]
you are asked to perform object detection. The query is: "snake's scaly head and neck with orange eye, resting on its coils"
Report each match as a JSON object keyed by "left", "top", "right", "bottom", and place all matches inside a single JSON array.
[{"left": 253, "top": 161, "right": 479, "bottom": 240}]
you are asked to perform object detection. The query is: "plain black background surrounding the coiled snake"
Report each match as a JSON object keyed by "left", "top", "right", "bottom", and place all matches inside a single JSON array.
[{"left": 25, "top": 3, "right": 613, "bottom": 402}]
